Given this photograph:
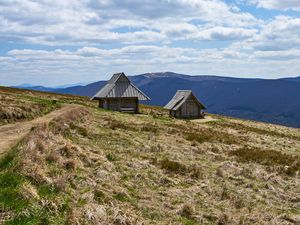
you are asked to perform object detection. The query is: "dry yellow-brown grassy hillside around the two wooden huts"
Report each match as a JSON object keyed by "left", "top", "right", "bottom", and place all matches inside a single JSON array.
[{"left": 0, "top": 89, "right": 300, "bottom": 225}]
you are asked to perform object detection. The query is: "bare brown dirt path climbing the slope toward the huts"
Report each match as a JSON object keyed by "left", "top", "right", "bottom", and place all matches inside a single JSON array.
[{"left": 0, "top": 105, "right": 80, "bottom": 156}]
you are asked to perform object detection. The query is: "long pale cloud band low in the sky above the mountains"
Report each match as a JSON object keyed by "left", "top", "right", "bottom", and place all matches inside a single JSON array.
[{"left": 0, "top": 45, "right": 300, "bottom": 86}]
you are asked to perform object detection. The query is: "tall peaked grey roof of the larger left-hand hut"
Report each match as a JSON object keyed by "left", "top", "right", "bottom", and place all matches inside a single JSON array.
[{"left": 92, "top": 73, "right": 150, "bottom": 100}]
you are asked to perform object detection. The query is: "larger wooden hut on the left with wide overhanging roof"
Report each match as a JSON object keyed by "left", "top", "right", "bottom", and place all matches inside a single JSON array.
[{"left": 92, "top": 73, "right": 150, "bottom": 113}]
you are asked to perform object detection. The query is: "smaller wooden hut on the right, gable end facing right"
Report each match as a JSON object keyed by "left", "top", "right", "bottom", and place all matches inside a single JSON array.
[{"left": 164, "top": 90, "right": 206, "bottom": 119}]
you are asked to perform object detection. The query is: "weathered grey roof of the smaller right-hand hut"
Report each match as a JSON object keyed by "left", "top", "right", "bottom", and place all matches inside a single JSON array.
[{"left": 164, "top": 90, "right": 206, "bottom": 110}]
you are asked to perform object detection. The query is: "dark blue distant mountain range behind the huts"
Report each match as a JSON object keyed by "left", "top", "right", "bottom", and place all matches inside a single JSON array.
[{"left": 11, "top": 72, "right": 300, "bottom": 128}]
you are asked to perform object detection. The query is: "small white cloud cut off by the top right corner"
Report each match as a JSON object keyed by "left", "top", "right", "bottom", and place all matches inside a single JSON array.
[{"left": 249, "top": 0, "right": 300, "bottom": 11}]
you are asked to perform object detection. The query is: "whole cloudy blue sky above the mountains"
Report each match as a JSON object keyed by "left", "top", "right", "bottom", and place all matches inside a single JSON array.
[{"left": 0, "top": 0, "right": 300, "bottom": 87}]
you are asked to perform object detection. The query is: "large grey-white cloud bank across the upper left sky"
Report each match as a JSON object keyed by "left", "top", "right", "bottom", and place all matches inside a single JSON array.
[{"left": 0, "top": 0, "right": 259, "bottom": 46}]
